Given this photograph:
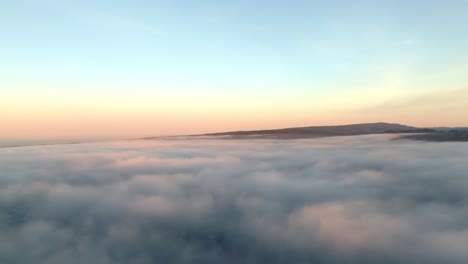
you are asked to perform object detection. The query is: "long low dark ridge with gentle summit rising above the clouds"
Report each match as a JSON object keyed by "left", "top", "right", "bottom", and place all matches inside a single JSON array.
[{"left": 192, "top": 122, "right": 435, "bottom": 138}]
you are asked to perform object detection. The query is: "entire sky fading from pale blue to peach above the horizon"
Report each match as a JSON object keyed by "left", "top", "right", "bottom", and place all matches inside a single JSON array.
[{"left": 0, "top": 0, "right": 468, "bottom": 139}]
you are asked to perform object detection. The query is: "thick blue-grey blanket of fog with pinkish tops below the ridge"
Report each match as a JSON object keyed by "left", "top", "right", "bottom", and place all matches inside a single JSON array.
[{"left": 0, "top": 135, "right": 468, "bottom": 264}]
